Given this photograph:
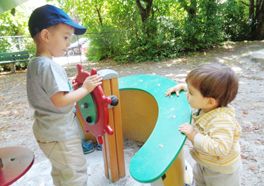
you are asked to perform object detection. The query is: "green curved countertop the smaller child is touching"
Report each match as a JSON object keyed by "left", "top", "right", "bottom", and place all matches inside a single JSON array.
[{"left": 119, "top": 74, "right": 191, "bottom": 183}]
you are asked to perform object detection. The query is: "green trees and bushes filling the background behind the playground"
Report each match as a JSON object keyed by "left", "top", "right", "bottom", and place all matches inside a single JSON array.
[{"left": 0, "top": 0, "right": 264, "bottom": 62}]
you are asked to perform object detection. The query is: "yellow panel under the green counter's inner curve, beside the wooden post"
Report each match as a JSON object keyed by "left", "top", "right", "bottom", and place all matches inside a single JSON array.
[{"left": 120, "top": 90, "right": 158, "bottom": 142}]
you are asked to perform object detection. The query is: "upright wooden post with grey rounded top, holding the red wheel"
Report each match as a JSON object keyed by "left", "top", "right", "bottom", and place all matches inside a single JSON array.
[{"left": 98, "top": 70, "right": 125, "bottom": 182}]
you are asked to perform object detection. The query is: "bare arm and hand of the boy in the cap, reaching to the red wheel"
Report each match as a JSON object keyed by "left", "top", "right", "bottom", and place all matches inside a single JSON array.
[{"left": 50, "top": 75, "right": 102, "bottom": 108}]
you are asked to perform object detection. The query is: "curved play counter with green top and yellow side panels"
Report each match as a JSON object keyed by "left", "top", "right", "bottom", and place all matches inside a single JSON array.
[{"left": 119, "top": 74, "right": 191, "bottom": 185}]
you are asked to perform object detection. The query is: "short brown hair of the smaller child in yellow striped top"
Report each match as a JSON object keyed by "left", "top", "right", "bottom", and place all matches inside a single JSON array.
[{"left": 186, "top": 63, "right": 238, "bottom": 107}]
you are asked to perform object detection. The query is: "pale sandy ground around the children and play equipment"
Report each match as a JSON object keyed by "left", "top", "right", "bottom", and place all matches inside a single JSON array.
[{"left": 0, "top": 41, "right": 264, "bottom": 186}]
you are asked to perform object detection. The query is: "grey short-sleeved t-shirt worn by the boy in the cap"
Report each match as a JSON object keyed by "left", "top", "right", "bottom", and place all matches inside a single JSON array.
[{"left": 27, "top": 57, "right": 79, "bottom": 141}]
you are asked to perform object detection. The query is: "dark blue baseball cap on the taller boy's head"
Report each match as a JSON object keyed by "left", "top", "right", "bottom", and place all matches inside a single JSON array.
[{"left": 28, "top": 5, "right": 86, "bottom": 37}]
